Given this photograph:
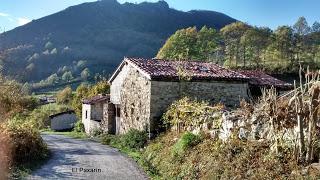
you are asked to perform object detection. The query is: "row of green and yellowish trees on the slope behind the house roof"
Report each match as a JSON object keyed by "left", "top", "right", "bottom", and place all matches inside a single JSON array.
[{"left": 157, "top": 17, "right": 320, "bottom": 73}]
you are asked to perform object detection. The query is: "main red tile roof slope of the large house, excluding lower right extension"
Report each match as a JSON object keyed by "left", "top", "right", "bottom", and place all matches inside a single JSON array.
[{"left": 125, "top": 58, "right": 248, "bottom": 81}]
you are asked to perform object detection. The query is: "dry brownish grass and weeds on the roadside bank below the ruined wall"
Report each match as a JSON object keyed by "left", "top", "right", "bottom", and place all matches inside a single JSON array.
[{"left": 143, "top": 132, "right": 308, "bottom": 179}]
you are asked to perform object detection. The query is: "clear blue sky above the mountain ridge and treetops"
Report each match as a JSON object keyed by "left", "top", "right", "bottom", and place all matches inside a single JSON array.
[{"left": 0, "top": 0, "right": 320, "bottom": 32}]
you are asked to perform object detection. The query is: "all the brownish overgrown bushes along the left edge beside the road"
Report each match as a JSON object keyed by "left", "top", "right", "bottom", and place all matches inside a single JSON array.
[{"left": 0, "top": 77, "right": 48, "bottom": 179}]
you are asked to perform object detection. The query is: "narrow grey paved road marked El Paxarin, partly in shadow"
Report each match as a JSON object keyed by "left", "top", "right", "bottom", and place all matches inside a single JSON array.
[{"left": 28, "top": 134, "right": 148, "bottom": 180}]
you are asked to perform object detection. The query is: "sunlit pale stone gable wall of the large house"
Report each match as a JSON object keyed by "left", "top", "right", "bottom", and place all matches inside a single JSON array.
[{"left": 119, "top": 66, "right": 151, "bottom": 134}]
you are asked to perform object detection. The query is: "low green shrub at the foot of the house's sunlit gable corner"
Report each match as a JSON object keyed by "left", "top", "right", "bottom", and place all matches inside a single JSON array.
[{"left": 120, "top": 129, "right": 148, "bottom": 149}]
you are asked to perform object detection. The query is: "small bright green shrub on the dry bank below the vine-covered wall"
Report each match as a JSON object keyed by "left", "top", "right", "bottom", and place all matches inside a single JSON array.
[{"left": 172, "top": 132, "right": 201, "bottom": 156}]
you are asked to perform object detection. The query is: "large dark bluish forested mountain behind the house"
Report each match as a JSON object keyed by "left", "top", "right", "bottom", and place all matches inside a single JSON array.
[{"left": 0, "top": 0, "right": 236, "bottom": 84}]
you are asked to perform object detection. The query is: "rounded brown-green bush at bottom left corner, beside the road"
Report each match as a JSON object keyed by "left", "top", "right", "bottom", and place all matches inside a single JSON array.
[{"left": 0, "top": 119, "right": 49, "bottom": 179}]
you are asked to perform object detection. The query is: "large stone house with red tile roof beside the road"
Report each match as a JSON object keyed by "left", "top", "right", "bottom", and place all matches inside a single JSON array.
[{"left": 102, "top": 58, "right": 291, "bottom": 134}]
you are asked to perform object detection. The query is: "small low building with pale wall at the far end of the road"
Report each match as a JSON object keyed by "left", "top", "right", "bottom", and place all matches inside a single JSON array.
[{"left": 49, "top": 111, "right": 77, "bottom": 131}]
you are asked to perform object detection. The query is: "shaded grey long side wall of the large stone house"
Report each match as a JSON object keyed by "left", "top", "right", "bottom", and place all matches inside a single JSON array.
[{"left": 150, "top": 81, "right": 248, "bottom": 132}]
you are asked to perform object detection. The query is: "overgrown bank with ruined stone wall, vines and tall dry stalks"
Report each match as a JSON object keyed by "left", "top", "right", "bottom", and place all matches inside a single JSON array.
[{"left": 140, "top": 71, "right": 320, "bottom": 179}]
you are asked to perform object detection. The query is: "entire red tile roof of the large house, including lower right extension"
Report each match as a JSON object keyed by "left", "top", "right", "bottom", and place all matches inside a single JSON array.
[{"left": 109, "top": 58, "right": 292, "bottom": 90}]
